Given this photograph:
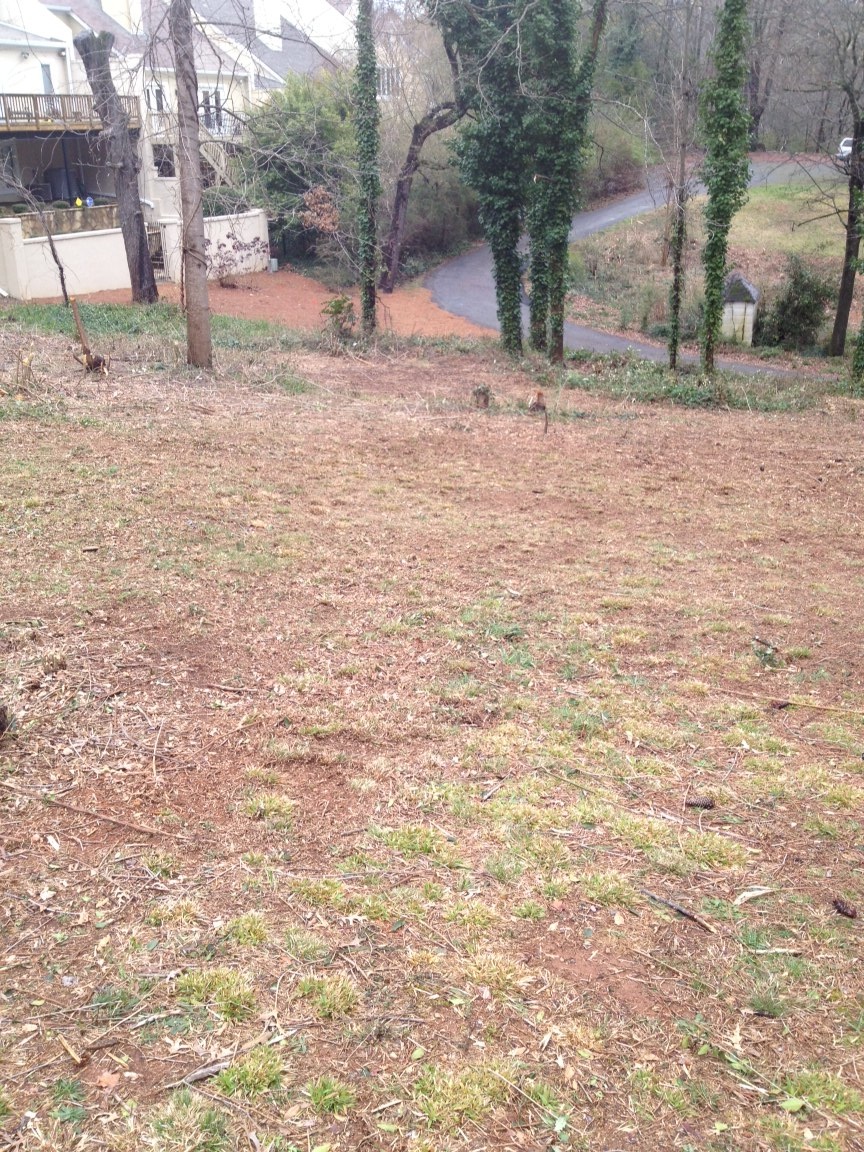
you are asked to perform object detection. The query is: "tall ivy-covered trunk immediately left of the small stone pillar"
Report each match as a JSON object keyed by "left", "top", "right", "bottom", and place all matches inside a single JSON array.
[{"left": 702, "top": 0, "right": 750, "bottom": 373}]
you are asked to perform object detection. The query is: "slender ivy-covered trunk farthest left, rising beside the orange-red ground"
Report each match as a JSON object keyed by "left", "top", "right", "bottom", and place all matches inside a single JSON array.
[{"left": 354, "top": 0, "right": 381, "bottom": 336}]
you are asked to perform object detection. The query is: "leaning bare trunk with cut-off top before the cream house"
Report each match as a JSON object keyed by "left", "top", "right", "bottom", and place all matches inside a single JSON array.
[{"left": 73, "top": 32, "right": 159, "bottom": 304}]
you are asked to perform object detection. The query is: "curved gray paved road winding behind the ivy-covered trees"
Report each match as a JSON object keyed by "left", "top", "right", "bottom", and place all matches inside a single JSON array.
[{"left": 425, "top": 160, "right": 842, "bottom": 373}]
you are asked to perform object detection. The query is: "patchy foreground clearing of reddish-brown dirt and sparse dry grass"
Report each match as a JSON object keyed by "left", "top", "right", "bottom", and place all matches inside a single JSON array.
[{"left": 0, "top": 313, "right": 864, "bottom": 1152}]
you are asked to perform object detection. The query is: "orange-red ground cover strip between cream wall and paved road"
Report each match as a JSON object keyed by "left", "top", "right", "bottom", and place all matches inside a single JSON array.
[{"left": 62, "top": 268, "right": 492, "bottom": 336}]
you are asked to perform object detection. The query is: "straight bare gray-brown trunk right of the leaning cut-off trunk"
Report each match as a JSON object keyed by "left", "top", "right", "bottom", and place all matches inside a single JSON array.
[{"left": 168, "top": 0, "right": 213, "bottom": 367}]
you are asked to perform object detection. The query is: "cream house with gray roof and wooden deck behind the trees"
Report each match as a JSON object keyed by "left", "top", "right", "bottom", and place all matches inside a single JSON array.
[{"left": 0, "top": 0, "right": 354, "bottom": 218}]
